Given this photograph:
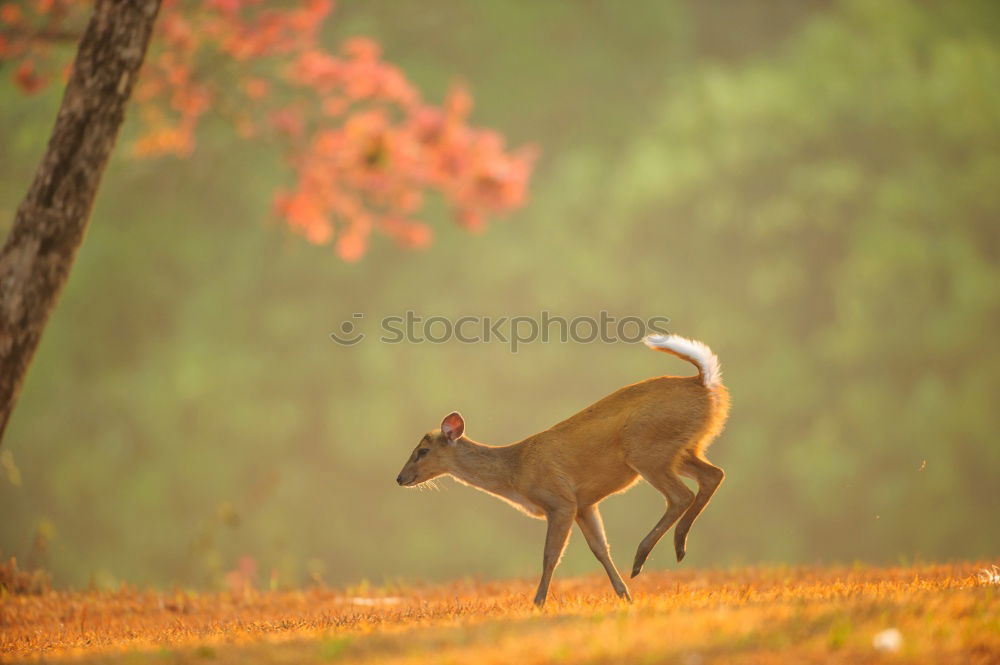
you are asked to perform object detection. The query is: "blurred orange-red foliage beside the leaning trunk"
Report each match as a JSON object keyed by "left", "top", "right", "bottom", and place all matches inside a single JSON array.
[{"left": 0, "top": 0, "right": 535, "bottom": 261}]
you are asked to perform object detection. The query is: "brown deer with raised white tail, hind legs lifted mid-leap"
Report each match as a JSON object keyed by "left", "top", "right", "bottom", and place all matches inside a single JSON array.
[{"left": 396, "top": 335, "right": 730, "bottom": 608}]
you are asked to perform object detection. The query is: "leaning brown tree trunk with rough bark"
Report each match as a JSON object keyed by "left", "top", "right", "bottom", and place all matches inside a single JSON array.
[{"left": 0, "top": 0, "right": 160, "bottom": 439}]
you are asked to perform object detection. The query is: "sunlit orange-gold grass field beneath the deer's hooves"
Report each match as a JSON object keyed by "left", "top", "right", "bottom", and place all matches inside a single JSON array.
[{"left": 0, "top": 563, "right": 1000, "bottom": 665}]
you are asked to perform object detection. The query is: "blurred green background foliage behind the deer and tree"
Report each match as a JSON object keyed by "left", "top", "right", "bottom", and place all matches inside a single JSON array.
[{"left": 0, "top": 0, "right": 1000, "bottom": 587}]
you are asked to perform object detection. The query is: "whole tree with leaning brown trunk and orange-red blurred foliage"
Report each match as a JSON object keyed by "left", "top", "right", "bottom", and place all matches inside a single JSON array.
[{"left": 0, "top": 0, "right": 534, "bottom": 437}]
